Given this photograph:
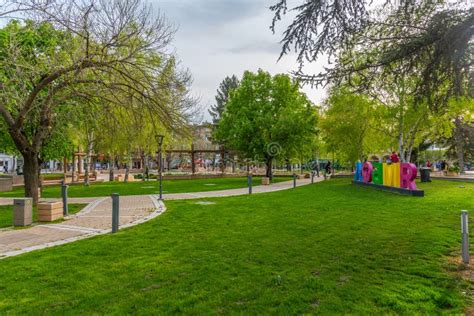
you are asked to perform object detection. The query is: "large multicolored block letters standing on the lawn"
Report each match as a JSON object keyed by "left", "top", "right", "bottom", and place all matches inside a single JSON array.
[{"left": 354, "top": 162, "right": 417, "bottom": 190}]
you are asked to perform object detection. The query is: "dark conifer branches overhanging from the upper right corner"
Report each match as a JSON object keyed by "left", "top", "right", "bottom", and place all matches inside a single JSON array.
[{"left": 271, "top": 0, "right": 474, "bottom": 109}]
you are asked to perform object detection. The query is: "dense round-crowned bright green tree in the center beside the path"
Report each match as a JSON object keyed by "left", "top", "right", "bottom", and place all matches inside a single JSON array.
[{"left": 215, "top": 70, "right": 317, "bottom": 178}]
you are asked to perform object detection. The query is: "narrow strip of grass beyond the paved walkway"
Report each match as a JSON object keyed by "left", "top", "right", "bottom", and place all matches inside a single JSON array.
[{"left": 0, "top": 177, "right": 291, "bottom": 198}]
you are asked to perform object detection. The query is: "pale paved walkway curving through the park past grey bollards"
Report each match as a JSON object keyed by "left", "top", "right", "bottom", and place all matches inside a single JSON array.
[{"left": 0, "top": 177, "right": 323, "bottom": 259}]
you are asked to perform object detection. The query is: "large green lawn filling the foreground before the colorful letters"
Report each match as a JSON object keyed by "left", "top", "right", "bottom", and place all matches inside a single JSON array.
[{"left": 0, "top": 179, "right": 474, "bottom": 315}]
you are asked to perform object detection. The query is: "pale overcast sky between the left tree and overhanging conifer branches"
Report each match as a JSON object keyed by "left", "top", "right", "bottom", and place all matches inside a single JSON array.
[{"left": 152, "top": 0, "right": 325, "bottom": 120}]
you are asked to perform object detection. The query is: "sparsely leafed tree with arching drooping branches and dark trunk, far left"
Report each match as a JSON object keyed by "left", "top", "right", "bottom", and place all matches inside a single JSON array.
[{"left": 0, "top": 0, "right": 193, "bottom": 202}]
